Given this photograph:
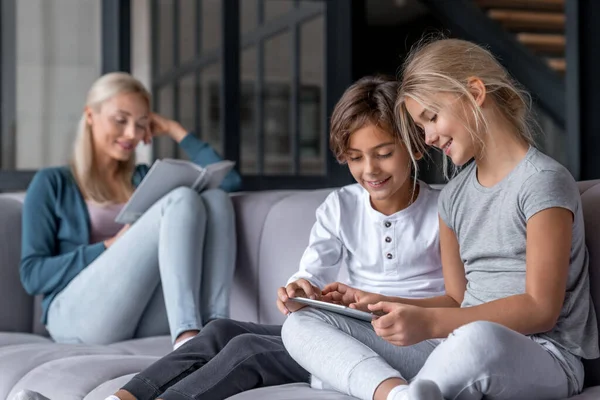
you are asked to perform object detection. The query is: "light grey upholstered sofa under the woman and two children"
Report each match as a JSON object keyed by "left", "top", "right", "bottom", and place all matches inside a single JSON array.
[{"left": 0, "top": 185, "right": 600, "bottom": 400}]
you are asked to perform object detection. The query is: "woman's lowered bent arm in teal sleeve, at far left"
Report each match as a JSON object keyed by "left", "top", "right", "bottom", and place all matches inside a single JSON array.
[{"left": 19, "top": 170, "right": 105, "bottom": 295}]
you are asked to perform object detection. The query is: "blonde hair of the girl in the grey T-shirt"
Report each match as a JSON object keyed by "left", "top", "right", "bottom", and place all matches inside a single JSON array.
[{"left": 395, "top": 39, "right": 536, "bottom": 178}]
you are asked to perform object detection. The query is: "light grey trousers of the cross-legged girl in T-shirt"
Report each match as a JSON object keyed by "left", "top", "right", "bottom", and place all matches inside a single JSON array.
[{"left": 282, "top": 307, "right": 583, "bottom": 400}]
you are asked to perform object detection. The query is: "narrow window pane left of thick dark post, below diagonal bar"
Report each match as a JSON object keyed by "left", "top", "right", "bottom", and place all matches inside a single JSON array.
[{"left": 199, "top": 63, "right": 223, "bottom": 155}]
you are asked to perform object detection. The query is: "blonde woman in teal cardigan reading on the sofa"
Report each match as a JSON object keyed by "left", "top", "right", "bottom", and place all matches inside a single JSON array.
[{"left": 20, "top": 73, "right": 240, "bottom": 346}]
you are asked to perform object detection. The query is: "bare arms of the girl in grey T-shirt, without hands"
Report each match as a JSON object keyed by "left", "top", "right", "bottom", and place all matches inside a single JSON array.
[{"left": 427, "top": 207, "right": 573, "bottom": 338}]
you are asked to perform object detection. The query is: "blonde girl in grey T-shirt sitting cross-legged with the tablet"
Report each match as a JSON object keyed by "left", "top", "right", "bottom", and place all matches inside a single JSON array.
[{"left": 282, "top": 39, "right": 598, "bottom": 400}]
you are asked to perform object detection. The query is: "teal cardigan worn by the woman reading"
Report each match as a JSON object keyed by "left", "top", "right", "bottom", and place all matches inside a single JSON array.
[{"left": 19, "top": 134, "right": 241, "bottom": 324}]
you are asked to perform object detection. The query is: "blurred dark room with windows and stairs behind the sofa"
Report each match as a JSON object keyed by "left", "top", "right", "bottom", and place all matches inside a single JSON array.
[{"left": 0, "top": 0, "right": 600, "bottom": 192}]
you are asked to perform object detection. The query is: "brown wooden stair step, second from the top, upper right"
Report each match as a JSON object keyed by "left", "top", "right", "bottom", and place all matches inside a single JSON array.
[{"left": 488, "top": 10, "right": 565, "bottom": 31}]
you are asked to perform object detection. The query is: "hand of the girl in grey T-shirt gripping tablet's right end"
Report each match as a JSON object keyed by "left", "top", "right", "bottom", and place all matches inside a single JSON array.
[{"left": 368, "top": 301, "right": 434, "bottom": 346}]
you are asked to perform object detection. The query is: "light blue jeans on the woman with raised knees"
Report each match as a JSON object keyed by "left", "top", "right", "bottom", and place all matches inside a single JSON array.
[{"left": 47, "top": 187, "right": 236, "bottom": 344}]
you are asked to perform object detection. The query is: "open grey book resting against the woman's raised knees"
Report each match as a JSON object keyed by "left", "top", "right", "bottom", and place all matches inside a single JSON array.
[{"left": 115, "top": 158, "right": 235, "bottom": 224}]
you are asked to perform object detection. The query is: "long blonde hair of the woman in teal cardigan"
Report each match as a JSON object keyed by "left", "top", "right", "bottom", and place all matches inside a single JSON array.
[{"left": 70, "top": 72, "right": 151, "bottom": 204}]
